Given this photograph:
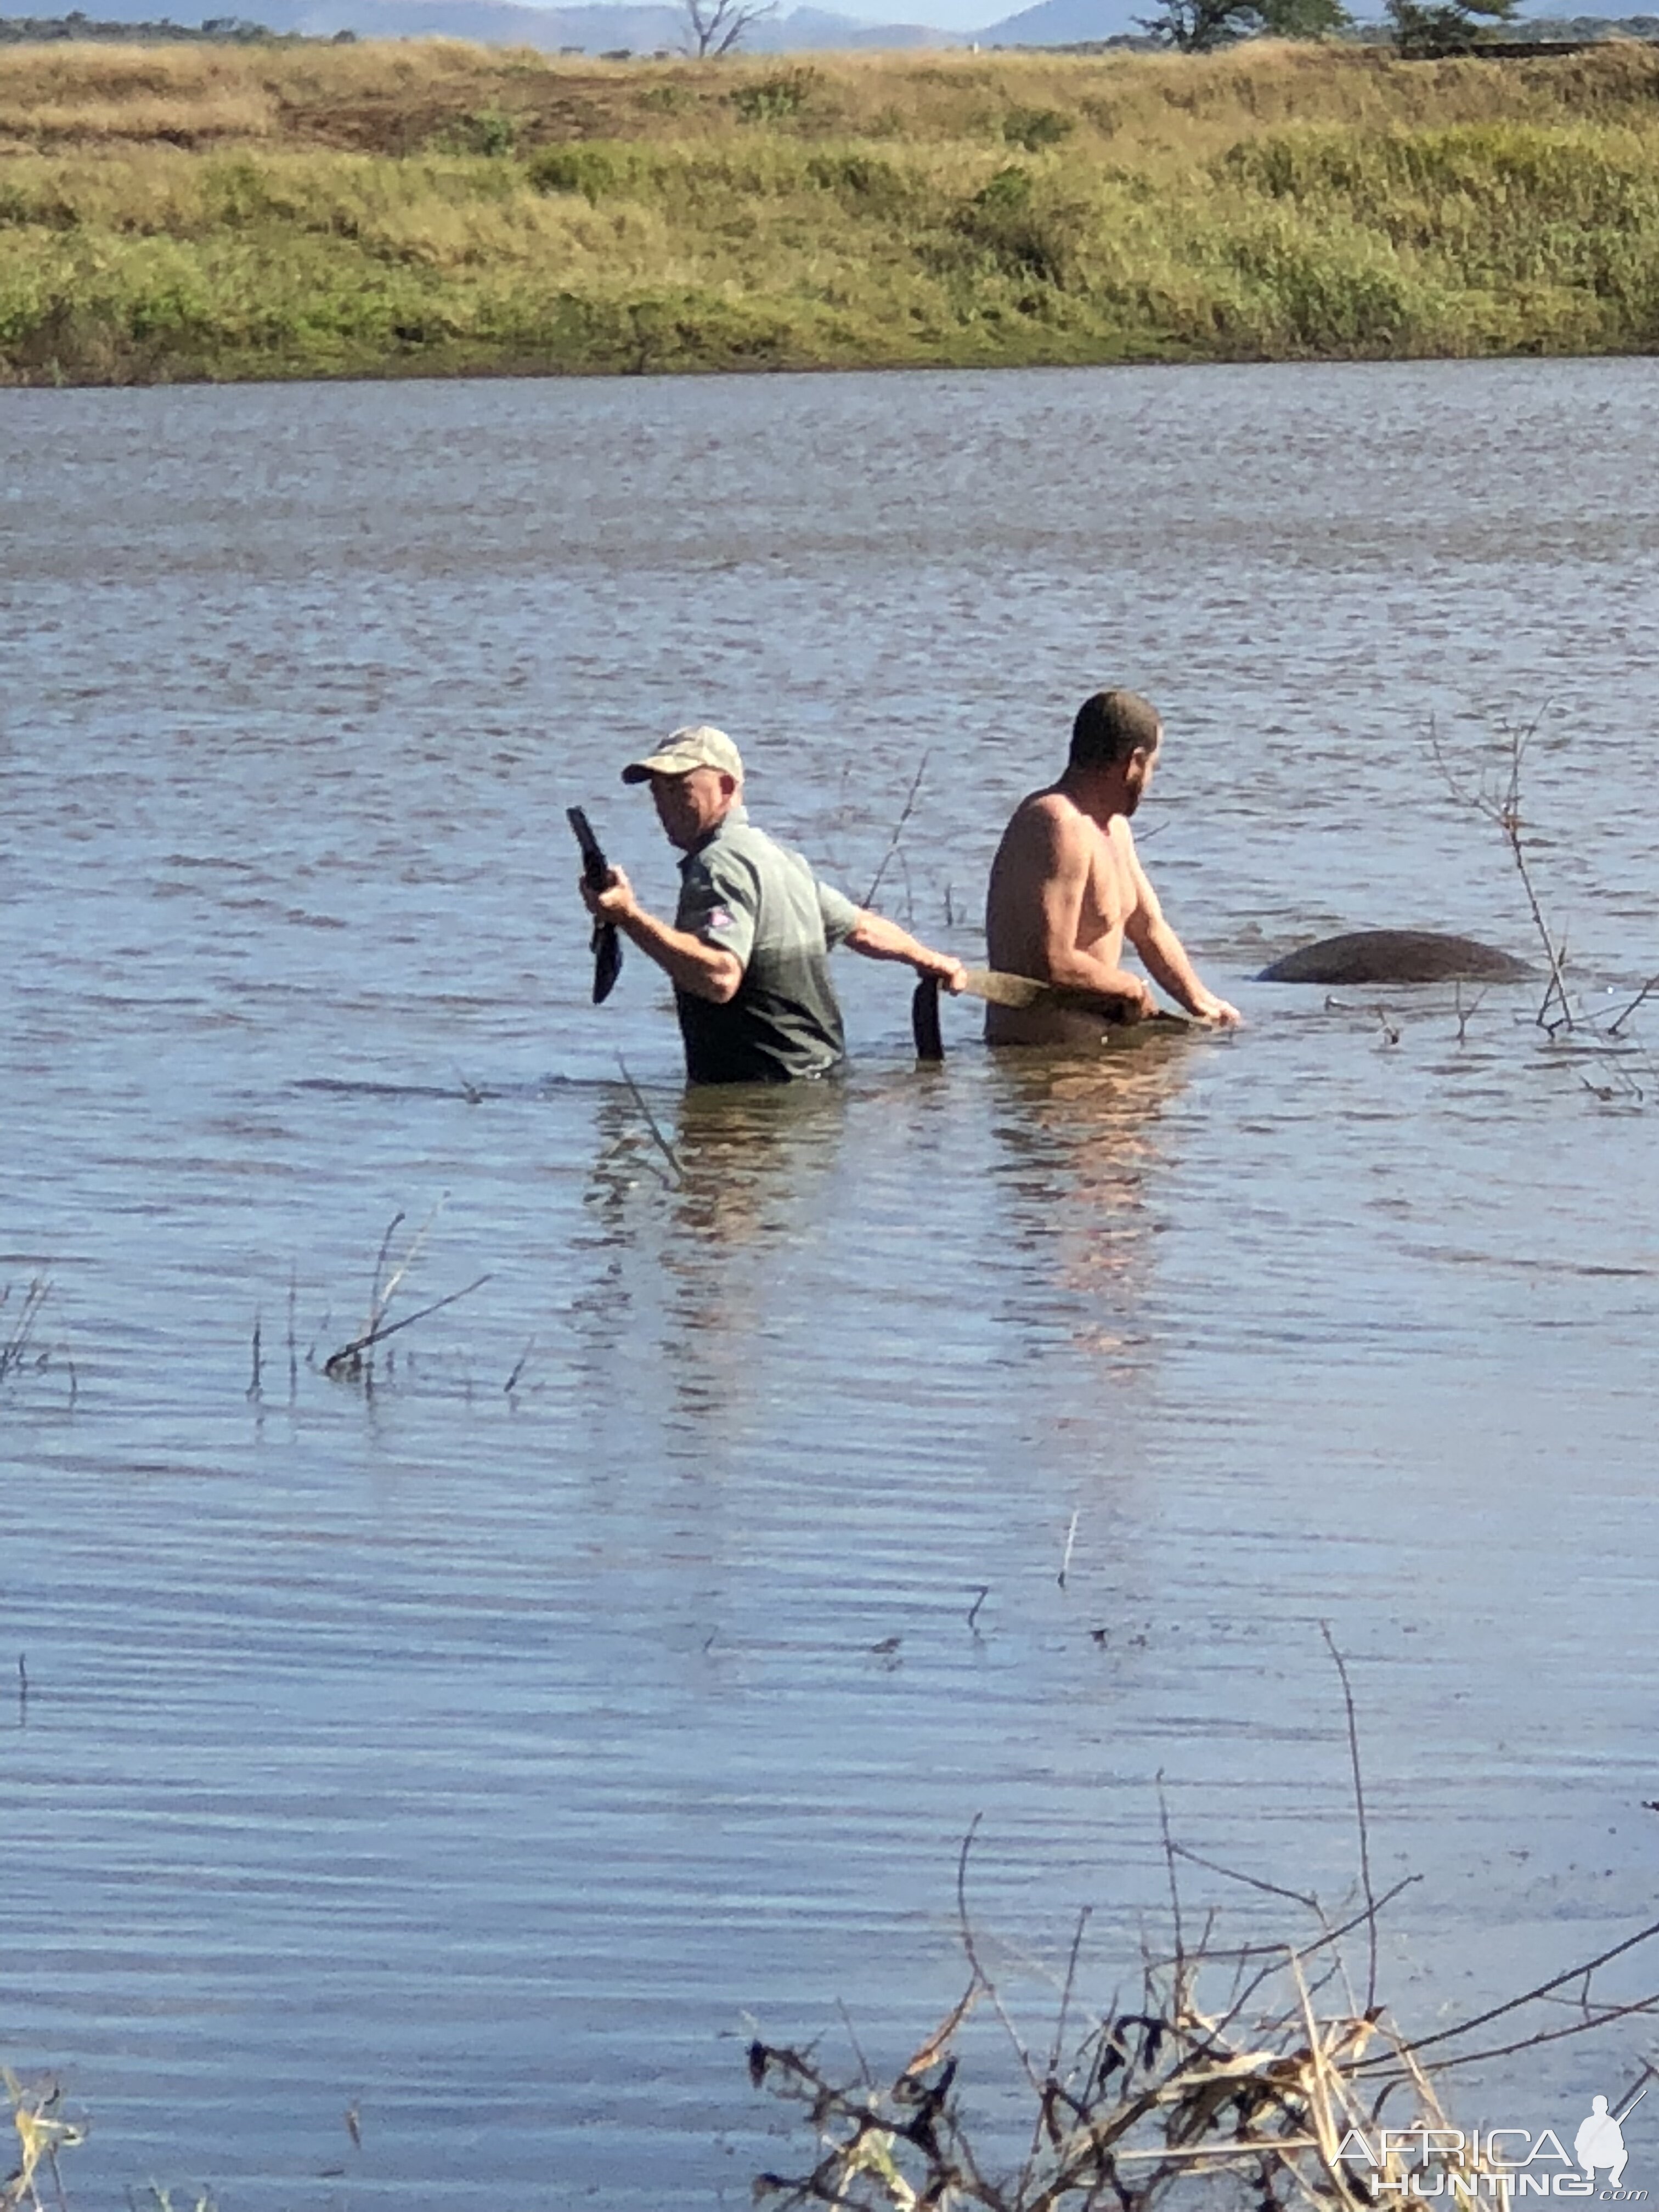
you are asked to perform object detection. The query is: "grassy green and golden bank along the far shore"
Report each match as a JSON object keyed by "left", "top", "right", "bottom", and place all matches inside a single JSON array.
[{"left": 0, "top": 44, "right": 1659, "bottom": 383}]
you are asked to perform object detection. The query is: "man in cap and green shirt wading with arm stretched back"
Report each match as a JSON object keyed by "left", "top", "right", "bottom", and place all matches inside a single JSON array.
[{"left": 582, "top": 723, "right": 962, "bottom": 1084}]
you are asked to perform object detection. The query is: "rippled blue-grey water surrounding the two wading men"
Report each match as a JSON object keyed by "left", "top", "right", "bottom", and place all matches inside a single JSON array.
[{"left": 0, "top": 363, "right": 1659, "bottom": 2212}]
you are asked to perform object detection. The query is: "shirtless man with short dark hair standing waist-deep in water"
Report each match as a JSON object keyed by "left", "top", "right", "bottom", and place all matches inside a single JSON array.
[{"left": 984, "top": 690, "right": 1239, "bottom": 1044}]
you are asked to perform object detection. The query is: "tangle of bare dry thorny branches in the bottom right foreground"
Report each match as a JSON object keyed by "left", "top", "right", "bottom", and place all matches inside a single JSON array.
[{"left": 750, "top": 1628, "right": 1659, "bottom": 2212}]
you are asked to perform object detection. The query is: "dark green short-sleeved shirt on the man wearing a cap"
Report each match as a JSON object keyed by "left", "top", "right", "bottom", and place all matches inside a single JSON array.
[{"left": 675, "top": 805, "right": 858, "bottom": 1084}]
